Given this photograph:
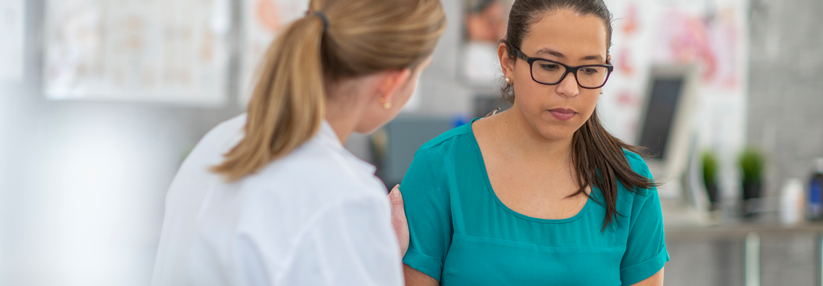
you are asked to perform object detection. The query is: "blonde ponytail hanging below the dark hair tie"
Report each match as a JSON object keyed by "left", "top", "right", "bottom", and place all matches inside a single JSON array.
[{"left": 211, "top": 15, "right": 325, "bottom": 181}]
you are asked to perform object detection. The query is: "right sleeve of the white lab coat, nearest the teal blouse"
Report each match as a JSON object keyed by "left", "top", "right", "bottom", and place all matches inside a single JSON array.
[{"left": 274, "top": 193, "right": 403, "bottom": 286}]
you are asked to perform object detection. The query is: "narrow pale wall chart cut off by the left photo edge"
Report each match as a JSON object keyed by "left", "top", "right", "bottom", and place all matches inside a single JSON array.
[{"left": 0, "top": 0, "right": 25, "bottom": 81}]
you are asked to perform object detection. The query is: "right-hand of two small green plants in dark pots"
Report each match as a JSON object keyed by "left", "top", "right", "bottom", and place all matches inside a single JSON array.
[{"left": 738, "top": 147, "right": 766, "bottom": 215}]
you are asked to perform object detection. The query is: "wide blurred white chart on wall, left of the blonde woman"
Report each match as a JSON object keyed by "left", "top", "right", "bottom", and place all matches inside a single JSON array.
[{"left": 44, "top": 0, "right": 231, "bottom": 105}]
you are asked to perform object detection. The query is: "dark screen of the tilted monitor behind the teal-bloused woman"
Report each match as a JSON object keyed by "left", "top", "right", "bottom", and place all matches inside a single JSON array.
[{"left": 640, "top": 77, "right": 684, "bottom": 160}]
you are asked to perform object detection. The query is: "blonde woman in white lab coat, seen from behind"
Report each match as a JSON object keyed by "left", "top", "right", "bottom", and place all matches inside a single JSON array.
[{"left": 152, "top": 0, "right": 445, "bottom": 285}]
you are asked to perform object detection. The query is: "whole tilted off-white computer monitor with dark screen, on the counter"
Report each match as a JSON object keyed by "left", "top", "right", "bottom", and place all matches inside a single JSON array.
[{"left": 635, "top": 65, "right": 699, "bottom": 199}]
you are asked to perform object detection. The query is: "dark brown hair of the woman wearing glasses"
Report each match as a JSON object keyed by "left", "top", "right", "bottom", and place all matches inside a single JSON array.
[{"left": 501, "top": 0, "right": 655, "bottom": 230}]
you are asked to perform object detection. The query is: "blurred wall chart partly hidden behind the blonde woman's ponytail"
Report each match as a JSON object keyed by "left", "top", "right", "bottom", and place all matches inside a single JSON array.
[{"left": 243, "top": 0, "right": 309, "bottom": 105}]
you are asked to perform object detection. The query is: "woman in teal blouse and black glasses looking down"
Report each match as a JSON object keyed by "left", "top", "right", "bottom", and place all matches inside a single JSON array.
[{"left": 392, "top": 0, "right": 669, "bottom": 285}]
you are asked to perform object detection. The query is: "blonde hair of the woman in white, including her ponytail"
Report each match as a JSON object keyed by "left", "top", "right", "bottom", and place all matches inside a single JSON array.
[{"left": 211, "top": 0, "right": 446, "bottom": 181}]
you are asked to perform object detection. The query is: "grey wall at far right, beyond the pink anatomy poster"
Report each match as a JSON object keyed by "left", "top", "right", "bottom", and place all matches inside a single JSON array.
[{"left": 747, "top": 0, "right": 823, "bottom": 195}]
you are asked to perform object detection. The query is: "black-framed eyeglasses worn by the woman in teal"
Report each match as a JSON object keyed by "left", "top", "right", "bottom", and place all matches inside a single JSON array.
[{"left": 509, "top": 45, "right": 614, "bottom": 89}]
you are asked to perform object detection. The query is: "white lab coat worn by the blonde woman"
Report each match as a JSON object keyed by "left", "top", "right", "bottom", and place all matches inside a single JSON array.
[{"left": 152, "top": 115, "right": 403, "bottom": 286}]
